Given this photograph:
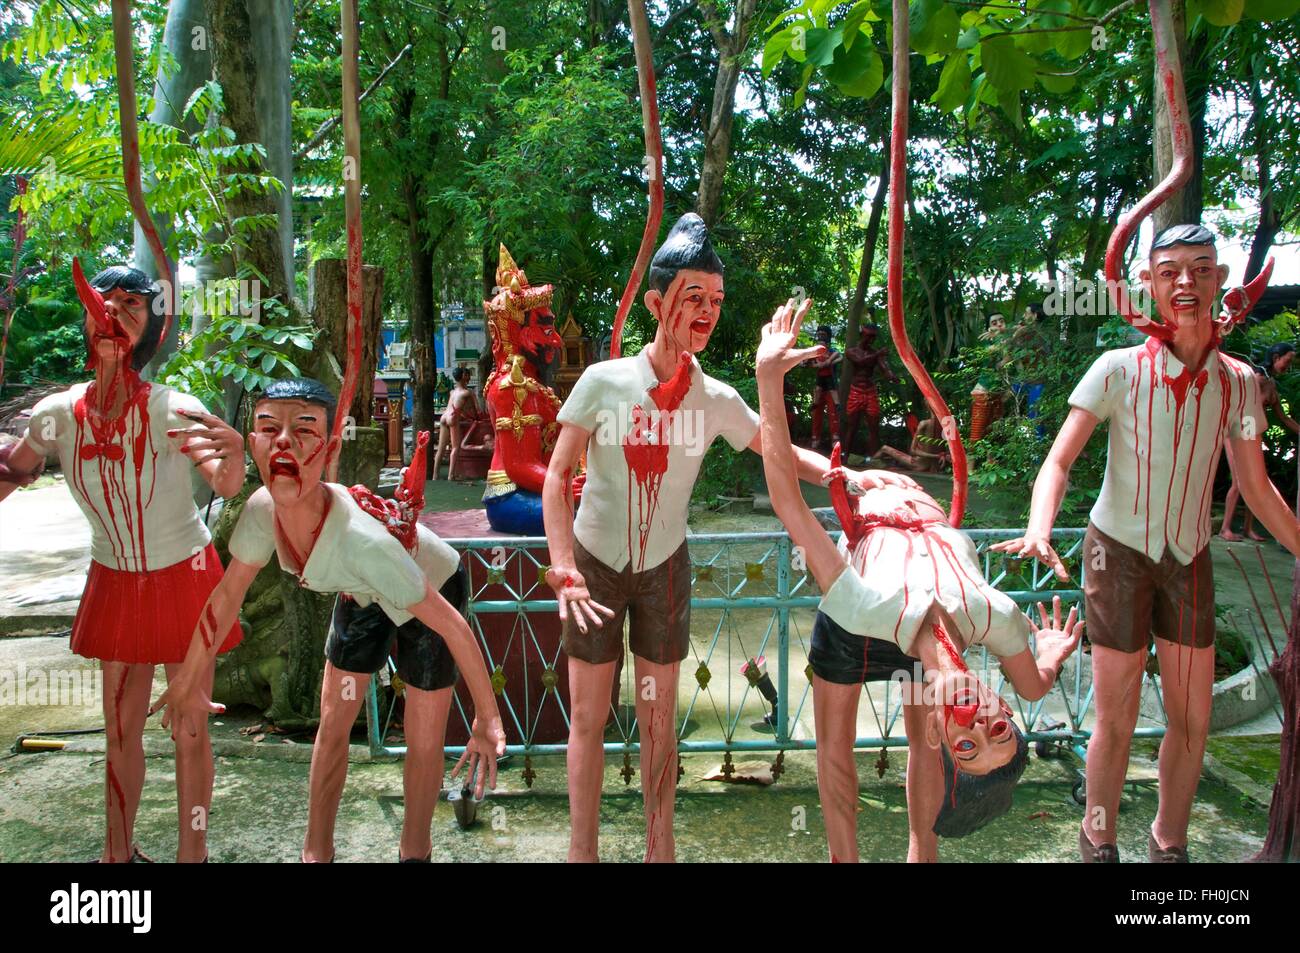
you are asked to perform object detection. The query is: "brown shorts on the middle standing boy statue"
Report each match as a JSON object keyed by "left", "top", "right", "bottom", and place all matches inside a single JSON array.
[{"left": 564, "top": 540, "right": 690, "bottom": 664}]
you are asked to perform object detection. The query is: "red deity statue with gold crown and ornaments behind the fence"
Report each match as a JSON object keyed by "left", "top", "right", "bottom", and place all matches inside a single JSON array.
[{"left": 484, "top": 244, "right": 574, "bottom": 536}]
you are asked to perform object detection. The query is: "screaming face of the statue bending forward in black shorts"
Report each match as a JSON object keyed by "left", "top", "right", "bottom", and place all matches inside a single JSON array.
[{"left": 248, "top": 399, "right": 332, "bottom": 506}]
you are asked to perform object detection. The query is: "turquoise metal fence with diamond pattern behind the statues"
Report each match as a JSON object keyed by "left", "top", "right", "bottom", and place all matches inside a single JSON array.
[{"left": 367, "top": 529, "right": 1164, "bottom": 777}]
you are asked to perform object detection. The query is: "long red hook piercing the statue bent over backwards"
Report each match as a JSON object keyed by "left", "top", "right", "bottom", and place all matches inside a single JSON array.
[{"left": 885, "top": 0, "right": 967, "bottom": 527}]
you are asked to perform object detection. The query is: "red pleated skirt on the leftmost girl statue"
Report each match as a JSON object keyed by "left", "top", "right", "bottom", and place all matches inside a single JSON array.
[{"left": 72, "top": 543, "right": 243, "bottom": 666}]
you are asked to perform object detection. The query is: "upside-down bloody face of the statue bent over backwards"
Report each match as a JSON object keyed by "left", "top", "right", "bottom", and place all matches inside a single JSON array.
[{"left": 935, "top": 672, "right": 1017, "bottom": 775}]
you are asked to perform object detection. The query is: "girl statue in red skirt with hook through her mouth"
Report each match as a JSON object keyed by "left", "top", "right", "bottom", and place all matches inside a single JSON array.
[{"left": 0, "top": 261, "right": 244, "bottom": 863}]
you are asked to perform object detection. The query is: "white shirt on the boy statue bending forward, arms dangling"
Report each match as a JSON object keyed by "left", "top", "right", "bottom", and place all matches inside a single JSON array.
[{"left": 230, "top": 484, "right": 460, "bottom": 625}]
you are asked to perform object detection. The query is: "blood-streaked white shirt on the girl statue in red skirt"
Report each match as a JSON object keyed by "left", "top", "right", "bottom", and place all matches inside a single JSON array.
[{"left": 25, "top": 384, "right": 212, "bottom": 572}]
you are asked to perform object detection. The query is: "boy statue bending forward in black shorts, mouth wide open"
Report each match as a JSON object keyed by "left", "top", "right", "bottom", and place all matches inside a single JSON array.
[{"left": 153, "top": 378, "right": 506, "bottom": 862}]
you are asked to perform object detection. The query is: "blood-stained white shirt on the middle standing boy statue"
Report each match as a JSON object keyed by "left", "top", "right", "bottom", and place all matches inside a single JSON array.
[{"left": 556, "top": 351, "right": 758, "bottom": 572}]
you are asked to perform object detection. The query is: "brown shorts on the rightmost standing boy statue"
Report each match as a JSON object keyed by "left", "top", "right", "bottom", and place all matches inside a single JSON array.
[{"left": 1083, "top": 523, "right": 1214, "bottom": 653}]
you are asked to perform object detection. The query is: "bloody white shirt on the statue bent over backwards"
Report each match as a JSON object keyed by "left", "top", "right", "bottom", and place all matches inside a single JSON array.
[{"left": 819, "top": 509, "right": 1032, "bottom": 658}]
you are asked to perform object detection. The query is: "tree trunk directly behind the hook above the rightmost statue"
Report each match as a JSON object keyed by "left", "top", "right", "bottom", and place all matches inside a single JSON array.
[{"left": 1152, "top": 0, "right": 1209, "bottom": 234}]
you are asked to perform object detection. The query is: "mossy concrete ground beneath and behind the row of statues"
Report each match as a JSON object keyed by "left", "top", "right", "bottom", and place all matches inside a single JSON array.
[{"left": 0, "top": 481, "right": 1292, "bottom": 862}]
